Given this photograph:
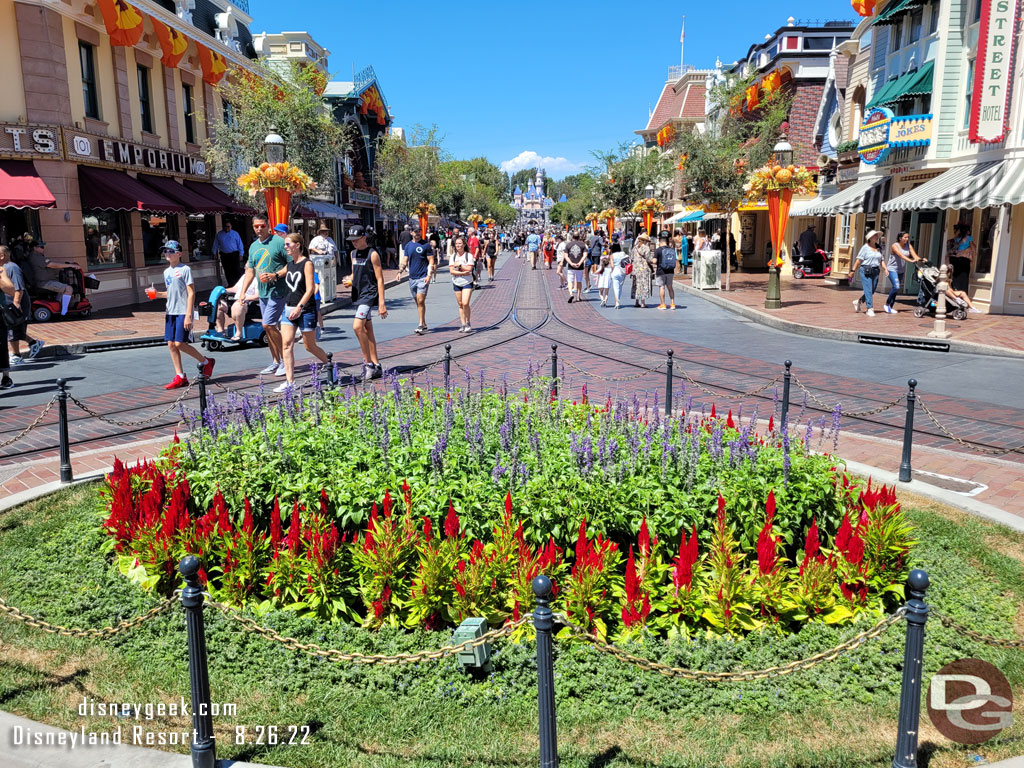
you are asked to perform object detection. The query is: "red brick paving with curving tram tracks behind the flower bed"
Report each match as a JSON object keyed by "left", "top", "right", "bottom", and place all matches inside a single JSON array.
[{"left": 0, "top": 259, "right": 1024, "bottom": 515}]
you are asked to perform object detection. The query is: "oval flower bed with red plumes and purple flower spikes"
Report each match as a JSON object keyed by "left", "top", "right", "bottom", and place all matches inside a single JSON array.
[{"left": 103, "top": 380, "right": 912, "bottom": 636}]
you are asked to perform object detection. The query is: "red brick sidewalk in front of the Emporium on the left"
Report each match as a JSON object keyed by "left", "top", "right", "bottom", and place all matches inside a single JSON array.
[{"left": 29, "top": 269, "right": 402, "bottom": 357}]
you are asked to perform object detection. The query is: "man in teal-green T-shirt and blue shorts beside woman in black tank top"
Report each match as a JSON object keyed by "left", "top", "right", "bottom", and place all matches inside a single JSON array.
[{"left": 231, "top": 214, "right": 288, "bottom": 376}]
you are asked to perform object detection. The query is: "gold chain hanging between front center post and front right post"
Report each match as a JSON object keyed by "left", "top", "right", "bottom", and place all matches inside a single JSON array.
[{"left": 556, "top": 606, "right": 906, "bottom": 683}]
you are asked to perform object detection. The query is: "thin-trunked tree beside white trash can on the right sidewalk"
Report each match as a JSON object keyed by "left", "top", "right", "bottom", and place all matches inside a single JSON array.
[{"left": 673, "top": 70, "right": 792, "bottom": 291}]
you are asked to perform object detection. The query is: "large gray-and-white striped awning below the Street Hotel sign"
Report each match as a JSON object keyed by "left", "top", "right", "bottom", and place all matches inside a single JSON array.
[{"left": 882, "top": 159, "right": 1024, "bottom": 211}]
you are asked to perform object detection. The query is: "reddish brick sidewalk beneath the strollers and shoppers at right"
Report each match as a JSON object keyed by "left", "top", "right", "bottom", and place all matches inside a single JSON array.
[{"left": 676, "top": 272, "right": 1024, "bottom": 352}]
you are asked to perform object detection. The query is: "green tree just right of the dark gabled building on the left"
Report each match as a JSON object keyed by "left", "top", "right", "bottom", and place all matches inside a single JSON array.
[{"left": 375, "top": 126, "right": 442, "bottom": 216}]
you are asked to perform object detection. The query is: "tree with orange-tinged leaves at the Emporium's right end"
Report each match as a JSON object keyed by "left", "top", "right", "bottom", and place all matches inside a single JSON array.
[{"left": 205, "top": 63, "right": 349, "bottom": 200}]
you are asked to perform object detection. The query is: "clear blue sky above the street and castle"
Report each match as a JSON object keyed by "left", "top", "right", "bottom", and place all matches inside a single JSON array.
[{"left": 250, "top": 0, "right": 857, "bottom": 178}]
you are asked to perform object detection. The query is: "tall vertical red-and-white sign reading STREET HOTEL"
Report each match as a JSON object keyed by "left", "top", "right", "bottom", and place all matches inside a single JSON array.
[{"left": 969, "top": 0, "right": 1020, "bottom": 143}]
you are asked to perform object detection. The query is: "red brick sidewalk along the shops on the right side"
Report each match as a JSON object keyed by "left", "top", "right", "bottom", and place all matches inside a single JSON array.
[{"left": 676, "top": 272, "right": 1024, "bottom": 357}]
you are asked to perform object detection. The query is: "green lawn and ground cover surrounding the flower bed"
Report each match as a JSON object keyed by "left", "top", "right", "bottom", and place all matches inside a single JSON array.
[{"left": 0, "top": 485, "right": 1024, "bottom": 768}]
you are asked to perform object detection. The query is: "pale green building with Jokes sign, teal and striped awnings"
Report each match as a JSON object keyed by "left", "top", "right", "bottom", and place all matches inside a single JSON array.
[{"left": 814, "top": 0, "right": 1024, "bottom": 314}]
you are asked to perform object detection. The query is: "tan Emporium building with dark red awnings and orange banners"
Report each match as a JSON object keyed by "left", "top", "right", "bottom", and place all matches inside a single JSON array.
[{"left": 0, "top": 0, "right": 264, "bottom": 308}]
